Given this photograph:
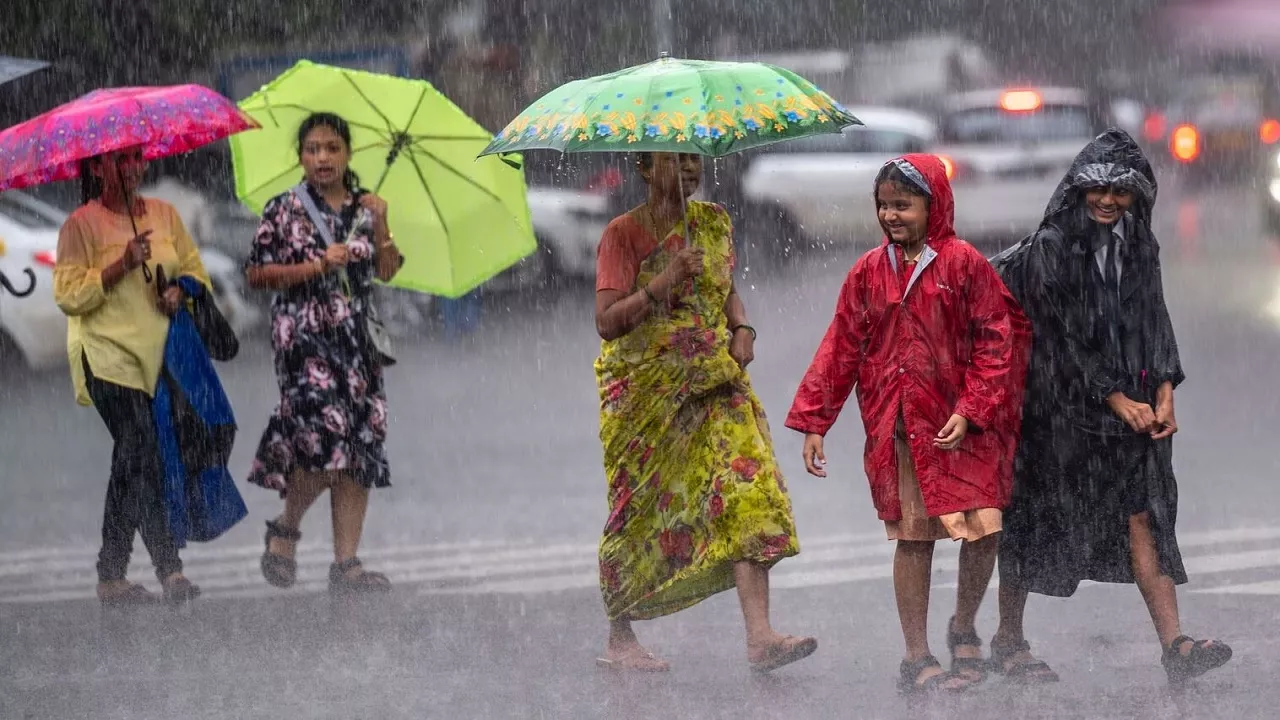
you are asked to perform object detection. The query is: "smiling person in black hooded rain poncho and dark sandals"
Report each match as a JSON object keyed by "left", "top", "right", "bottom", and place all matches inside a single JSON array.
[{"left": 991, "top": 129, "right": 1231, "bottom": 682}]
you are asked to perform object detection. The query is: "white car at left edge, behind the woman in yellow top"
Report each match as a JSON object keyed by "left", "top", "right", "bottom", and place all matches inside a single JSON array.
[{"left": 0, "top": 191, "right": 261, "bottom": 370}]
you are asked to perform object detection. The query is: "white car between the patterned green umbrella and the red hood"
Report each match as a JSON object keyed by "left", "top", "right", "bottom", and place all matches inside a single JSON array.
[{"left": 742, "top": 108, "right": 936, "bottom": 245}]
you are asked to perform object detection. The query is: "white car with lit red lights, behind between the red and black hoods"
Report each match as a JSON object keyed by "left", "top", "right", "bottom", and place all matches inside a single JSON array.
[{"left": 932, "top": 87, "right": 1101, "bottom": 243}]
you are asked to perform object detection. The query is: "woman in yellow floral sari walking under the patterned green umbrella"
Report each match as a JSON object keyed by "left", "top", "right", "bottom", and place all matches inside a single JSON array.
[{"left": 595, "top": 152, "right": 818, "bottom": 671}]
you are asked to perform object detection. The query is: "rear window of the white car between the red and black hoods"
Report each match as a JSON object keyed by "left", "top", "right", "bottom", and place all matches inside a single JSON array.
[{"left": 942, "top": 105, "right": 1093, "bottom": 143}]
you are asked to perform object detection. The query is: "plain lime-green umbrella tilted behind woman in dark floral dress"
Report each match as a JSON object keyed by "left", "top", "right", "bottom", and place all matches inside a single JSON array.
[{"left": 232, "top": 60, "right": 536, "bottom": 297}]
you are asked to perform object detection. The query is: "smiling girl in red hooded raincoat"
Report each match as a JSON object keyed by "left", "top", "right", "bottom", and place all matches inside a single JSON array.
[{"left": 786, "top": 155, "right": 1030, "bottom": 692}]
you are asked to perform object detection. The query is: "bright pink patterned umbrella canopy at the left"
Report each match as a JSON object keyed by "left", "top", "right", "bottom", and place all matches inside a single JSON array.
[{"left": 0, "top": 85, "right": 257, "bottom": 191}]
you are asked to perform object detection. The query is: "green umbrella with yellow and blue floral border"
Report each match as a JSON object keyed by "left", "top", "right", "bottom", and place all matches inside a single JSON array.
[{"left": 481, "top": 56, "right": 861, "bottom": 156}]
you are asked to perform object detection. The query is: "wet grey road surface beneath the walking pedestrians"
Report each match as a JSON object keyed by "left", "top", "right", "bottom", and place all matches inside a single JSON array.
[{"left": 0, "top": 183, "right": 1280, "bottom": 719}]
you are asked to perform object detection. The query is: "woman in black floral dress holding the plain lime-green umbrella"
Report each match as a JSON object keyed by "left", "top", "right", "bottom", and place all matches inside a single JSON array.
[{"left": 240, "top": 113, "right": 403, "bottom": 592}]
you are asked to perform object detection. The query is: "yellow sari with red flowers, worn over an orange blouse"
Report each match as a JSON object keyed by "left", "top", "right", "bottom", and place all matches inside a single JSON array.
[{"left": 595, "top": 202, "right": 800, "bottom": 620}]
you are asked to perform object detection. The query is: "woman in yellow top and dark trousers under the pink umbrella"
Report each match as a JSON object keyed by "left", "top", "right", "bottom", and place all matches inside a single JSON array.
[{"left": 54, "top": 149, "right": 210, "bottom": 605}]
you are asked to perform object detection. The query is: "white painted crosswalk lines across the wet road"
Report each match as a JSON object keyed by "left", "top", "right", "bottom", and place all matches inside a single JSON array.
[{"left": 0, "top": 527, "right": 1280, "bottom": 603}]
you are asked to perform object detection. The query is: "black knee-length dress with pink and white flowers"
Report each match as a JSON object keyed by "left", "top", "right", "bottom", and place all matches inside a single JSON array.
[{"left": 246, "top": 186, "right": 390, "bottom": 496}]
